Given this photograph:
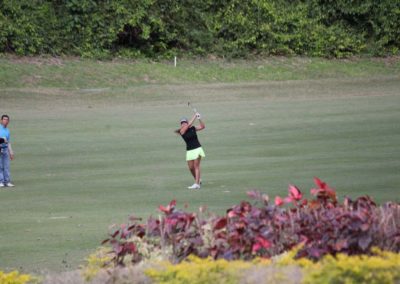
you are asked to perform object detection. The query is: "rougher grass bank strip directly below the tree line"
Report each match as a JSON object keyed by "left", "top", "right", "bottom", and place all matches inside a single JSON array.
[{"left": 0, "top": 57, "right": 400, "bottom": 89}]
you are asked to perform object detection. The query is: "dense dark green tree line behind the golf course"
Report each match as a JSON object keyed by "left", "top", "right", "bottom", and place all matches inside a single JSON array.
[{"left": 0, "top": 0, "right": 400, "bottom": 58}]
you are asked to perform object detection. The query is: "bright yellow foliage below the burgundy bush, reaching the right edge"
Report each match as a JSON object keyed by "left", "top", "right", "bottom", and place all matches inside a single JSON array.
[{"left": 145, "top": 249, "right": 400, "bottom": 284}]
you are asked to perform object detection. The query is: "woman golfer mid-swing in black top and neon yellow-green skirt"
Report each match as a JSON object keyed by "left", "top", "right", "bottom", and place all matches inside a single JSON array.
[{"left": 175, "top": 112, "right": 206, "bottom": 189}]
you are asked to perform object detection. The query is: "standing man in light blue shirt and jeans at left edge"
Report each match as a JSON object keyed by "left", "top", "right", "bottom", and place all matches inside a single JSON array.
[{"left": 0, "top": 114, "right": 14, "bottom": 187}]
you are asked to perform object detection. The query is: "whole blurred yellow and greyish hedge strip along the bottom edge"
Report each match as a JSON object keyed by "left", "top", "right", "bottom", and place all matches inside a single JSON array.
[{"left": 0, "top": 249, "right": 400, "bottom": 284}]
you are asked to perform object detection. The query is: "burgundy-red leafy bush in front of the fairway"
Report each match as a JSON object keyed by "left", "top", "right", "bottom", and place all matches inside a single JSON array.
[{"left": 103, "top": 178, "right": 400, "bottom": 264}]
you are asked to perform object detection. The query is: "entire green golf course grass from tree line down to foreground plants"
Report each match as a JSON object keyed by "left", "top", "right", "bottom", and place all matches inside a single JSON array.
[{"left": 0, "top": 56, "right": 400, "bottom": 272}]
